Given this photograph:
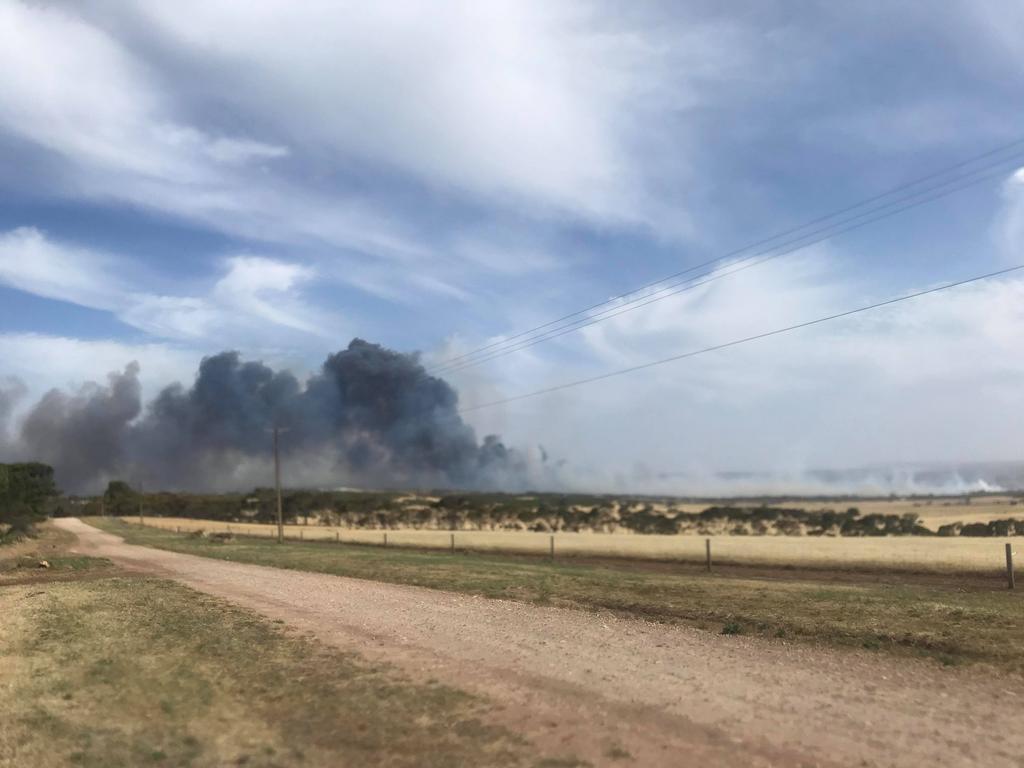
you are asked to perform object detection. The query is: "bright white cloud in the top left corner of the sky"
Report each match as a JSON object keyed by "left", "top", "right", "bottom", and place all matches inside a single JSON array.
[{"left": 0, "top": 2, "right": 288, "bottom": 183}]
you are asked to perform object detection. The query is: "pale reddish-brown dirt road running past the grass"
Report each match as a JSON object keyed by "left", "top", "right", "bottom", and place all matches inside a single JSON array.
[{"left": 57, "top": 519, "right": 1024, "bottom": 767}]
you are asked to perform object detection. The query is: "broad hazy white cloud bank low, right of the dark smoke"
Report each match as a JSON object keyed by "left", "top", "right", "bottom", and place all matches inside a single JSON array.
[{"left": 453, "top": 256, "right": 1024, "bottom": 492}]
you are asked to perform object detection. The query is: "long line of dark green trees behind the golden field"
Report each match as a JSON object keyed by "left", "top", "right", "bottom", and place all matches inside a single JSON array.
[{"left": 79, "top": 482, "right": 1024, "bottom": 537}]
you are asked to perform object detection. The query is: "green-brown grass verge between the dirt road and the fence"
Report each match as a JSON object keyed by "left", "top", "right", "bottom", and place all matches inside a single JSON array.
[{"left": 89, "top": 518, "right": 1024, "bottom": 672}]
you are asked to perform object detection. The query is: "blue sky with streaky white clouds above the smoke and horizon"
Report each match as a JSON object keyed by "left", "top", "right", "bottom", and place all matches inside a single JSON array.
[{"left": 0, "top": 0, "right": 1024, "bottom": 493}]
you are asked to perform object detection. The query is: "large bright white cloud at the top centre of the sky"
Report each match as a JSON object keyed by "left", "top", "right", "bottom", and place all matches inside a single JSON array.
[{"left": 116, "top": 1, "right": 667, "bottom": 225}]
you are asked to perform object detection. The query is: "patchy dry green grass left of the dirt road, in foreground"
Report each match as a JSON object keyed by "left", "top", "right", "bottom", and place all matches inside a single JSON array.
[{"left": 0, "top": 577, "right": 561, "bottom": 768}]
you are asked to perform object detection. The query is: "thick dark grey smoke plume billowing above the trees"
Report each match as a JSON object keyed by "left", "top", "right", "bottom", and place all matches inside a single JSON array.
[{"left": 0, "top": 339, "right": 527, "bottom": 493}]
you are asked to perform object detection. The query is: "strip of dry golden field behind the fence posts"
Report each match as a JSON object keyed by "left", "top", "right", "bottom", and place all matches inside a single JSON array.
[{"left": 134, "top": 517, "right": 1024, "bottom": 572}]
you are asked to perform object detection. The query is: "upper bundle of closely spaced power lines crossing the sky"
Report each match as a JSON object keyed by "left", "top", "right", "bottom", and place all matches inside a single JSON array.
[{"left": 431, "top": 138, "right": 1024, "bottom": 374}]
